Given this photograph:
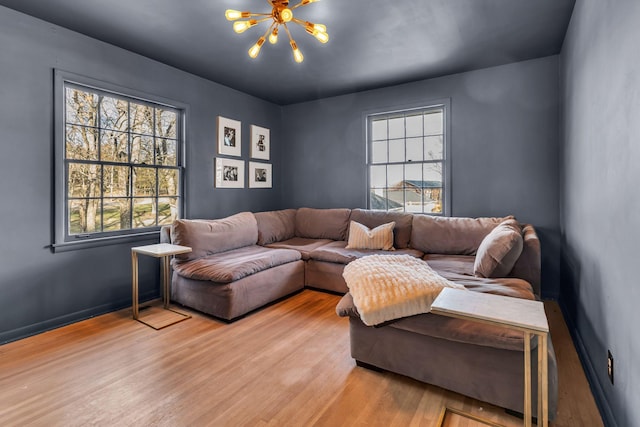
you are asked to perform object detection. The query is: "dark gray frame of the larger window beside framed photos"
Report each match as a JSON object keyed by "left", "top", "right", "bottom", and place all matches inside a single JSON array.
[{"left": 51, "top": 70, "right": 188, "bottom": 252}]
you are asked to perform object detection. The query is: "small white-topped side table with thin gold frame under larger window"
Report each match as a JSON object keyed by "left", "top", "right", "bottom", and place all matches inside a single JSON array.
[{"left": 131, "top": 243, "right": 191, "bottom": 329}]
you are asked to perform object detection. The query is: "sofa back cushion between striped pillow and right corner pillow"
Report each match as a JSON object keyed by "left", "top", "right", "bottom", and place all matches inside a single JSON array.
[{"left": 411, "top": 214, "right": 513, "bottom": 255}]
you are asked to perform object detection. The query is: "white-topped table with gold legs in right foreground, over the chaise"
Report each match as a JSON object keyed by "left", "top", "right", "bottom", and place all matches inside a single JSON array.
[{"left": 431, "top": 288, "right": 549, "bottom": 427}]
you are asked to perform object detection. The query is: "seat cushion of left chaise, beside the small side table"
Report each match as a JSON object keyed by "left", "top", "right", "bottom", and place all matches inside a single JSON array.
[{"left": 173, "top": 245, "right": 300, "bottom": 283}]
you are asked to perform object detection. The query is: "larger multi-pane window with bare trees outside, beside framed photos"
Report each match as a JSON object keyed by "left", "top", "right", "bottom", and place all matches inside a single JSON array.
[{"left": 56, "top": 72, "right": 183, "bottom": 249}]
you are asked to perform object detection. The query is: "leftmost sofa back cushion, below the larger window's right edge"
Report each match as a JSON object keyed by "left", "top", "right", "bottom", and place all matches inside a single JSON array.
[{"left": 171, "top": 212, "right": 258, "bottom": 262}]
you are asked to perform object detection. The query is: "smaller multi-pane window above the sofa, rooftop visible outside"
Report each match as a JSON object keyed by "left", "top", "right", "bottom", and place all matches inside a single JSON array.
[{"left": 367, "top": 104, "right": 448, "bottom": 215}]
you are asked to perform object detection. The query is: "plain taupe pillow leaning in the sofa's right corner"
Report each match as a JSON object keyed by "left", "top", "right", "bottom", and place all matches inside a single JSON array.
[{"left": 473, "top": 219, "right": 522, "bottom": 278}]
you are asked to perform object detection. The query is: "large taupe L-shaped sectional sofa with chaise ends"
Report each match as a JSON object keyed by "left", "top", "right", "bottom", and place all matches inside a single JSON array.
[{"left": 161, "top": 208, "right": 557, "bottom": 419}]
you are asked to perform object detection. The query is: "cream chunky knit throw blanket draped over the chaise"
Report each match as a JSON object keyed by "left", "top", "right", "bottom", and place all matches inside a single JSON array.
[{"left": 342, "top": 255, "right": 465, "bottom": 326}]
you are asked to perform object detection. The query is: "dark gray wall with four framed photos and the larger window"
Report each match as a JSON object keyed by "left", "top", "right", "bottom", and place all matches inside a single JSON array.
[{"left": 0, "top": 7, "right": 281, "bottom": 343}]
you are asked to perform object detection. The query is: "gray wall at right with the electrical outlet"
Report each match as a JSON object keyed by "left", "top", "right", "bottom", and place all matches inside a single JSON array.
[{"left": 561, "top": 0, "right": 640, "bottom": 426}]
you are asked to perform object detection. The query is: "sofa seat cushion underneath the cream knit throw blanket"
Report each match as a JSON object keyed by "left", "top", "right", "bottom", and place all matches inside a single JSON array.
[{"left": 336, "top": 276, "right": 536, "bottom": 351}]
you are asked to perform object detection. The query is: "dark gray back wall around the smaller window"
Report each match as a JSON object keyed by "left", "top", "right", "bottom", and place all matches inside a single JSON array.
[{"left": 283, "top": 56, "right": 560, "bottom": 297}]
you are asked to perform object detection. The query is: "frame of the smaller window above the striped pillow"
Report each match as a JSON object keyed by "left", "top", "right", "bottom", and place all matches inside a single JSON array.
[{"left": 364, "top": 98, "right": 451, "bottom": 216}]
